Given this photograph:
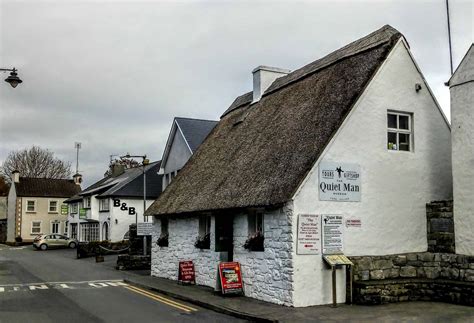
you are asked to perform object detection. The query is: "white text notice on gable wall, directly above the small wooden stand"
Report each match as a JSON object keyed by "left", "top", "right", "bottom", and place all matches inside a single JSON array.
[{"left": 321, "top": 215, "right": 344, "bottom": 255}]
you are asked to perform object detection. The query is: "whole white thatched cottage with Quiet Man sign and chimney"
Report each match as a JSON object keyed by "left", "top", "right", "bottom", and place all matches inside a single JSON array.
[{"left": 146, "top": 25, "right": 452, "bottom": 307}]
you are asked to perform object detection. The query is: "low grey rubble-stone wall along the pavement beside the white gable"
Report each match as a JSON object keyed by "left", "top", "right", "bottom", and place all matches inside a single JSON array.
[{"left": 350, "top": 252, "right": 474, "bottom": 305}]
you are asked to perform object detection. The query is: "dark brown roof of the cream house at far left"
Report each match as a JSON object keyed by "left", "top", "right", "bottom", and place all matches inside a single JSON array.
[{"left": 14, "top": 177, "right": 81, "bottom": 197}]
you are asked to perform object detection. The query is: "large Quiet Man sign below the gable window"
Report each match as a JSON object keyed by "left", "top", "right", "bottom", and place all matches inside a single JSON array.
[{"left": 319, "top": 162, "right": 361, "bottom": 202}]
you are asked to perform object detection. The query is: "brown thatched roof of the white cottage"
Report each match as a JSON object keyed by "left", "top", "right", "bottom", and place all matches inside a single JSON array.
[{"left": 147, "top": 26, "right": 401, "bottom": 215}]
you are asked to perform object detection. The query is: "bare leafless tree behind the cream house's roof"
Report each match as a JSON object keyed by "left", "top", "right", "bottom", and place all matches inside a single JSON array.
[{"left": 0, "top": 146, "right": 71, "bottom": 182}]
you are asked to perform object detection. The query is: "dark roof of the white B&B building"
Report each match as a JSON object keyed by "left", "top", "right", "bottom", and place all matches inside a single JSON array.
[{"left": 79, "top": 161, "right": 162, "bottom": 201}]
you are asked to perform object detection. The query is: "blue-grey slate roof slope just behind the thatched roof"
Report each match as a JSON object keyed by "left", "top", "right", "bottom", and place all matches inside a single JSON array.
[{"left": 174, "top": 117, "right": 217, "bottom": 154}]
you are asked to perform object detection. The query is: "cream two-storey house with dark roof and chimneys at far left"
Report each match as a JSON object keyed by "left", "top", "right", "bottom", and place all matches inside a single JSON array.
[{"left": 7, "top": 171, "right": 81, "bottom": 242}]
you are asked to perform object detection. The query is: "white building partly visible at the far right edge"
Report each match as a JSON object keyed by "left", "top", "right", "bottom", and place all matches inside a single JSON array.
[{"left": 446, "top": 45, "right": 474, "bottom": 256}]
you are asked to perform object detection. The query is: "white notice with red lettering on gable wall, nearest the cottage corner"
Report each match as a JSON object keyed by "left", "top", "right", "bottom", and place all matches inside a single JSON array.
[{"left": 296, "top": 214, "right": 321, "bottom": 255}]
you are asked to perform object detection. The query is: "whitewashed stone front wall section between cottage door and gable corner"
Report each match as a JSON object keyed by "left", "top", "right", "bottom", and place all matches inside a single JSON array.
[{"left": 234, "top": 207, "right": 293, "bottom": 306}]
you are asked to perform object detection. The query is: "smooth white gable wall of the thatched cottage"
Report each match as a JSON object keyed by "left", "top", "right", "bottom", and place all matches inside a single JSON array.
[{"left": 293, "top": 41, "right": 452, "bottom": 306}]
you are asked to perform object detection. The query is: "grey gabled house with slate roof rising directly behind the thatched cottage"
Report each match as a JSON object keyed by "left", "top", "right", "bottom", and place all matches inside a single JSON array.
[{"left": 160, "top": 117, "right": 217, "bottom": 190}]
